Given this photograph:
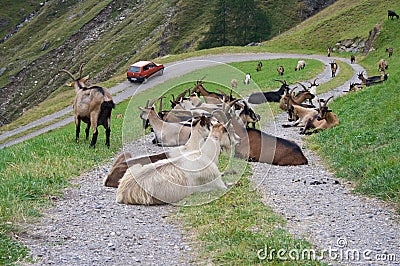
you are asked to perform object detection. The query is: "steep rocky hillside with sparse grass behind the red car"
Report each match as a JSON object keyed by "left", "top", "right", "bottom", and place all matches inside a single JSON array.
[{"left": 0, "top": 0, "right": 334, "bottom": 124}]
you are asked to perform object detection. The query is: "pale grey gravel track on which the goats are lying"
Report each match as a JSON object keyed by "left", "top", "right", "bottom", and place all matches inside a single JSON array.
[{"left": 16, "top": 54, "right": 400, "bottom": 265}]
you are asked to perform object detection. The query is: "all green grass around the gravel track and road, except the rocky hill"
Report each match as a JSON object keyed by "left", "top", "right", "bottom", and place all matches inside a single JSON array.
[{"left": 0, "top": 0, "right": 400, "bottom": 265}]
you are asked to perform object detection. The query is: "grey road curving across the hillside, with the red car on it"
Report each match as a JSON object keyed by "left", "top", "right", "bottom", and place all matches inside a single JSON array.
[{"left": 0, "top": 53, "right": 365, "bottom": 149}]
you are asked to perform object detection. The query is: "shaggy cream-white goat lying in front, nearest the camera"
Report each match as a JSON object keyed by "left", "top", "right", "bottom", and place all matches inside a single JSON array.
[{"left": 116, "top": 123, "right": 238, "bottom": 205}]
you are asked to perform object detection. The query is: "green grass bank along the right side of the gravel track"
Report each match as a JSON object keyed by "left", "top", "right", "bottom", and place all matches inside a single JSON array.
[{"left": 310, "top": 17, "right": 400, "bottom": 210}]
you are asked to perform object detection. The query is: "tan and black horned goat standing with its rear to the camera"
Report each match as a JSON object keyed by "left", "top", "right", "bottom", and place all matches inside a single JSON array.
[{"left": 60, "top": 64, "right": 115, "bottom": 148}]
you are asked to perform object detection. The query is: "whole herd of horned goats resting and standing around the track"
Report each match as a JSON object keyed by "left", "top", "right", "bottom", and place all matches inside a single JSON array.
[{"left": 61, "top": 50, "right": 393, "bottom": 205}]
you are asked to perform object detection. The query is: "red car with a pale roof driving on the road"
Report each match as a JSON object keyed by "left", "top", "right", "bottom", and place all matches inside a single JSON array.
[{"left": 126, "top": 61, "right": 164, "bottom": 82}]
